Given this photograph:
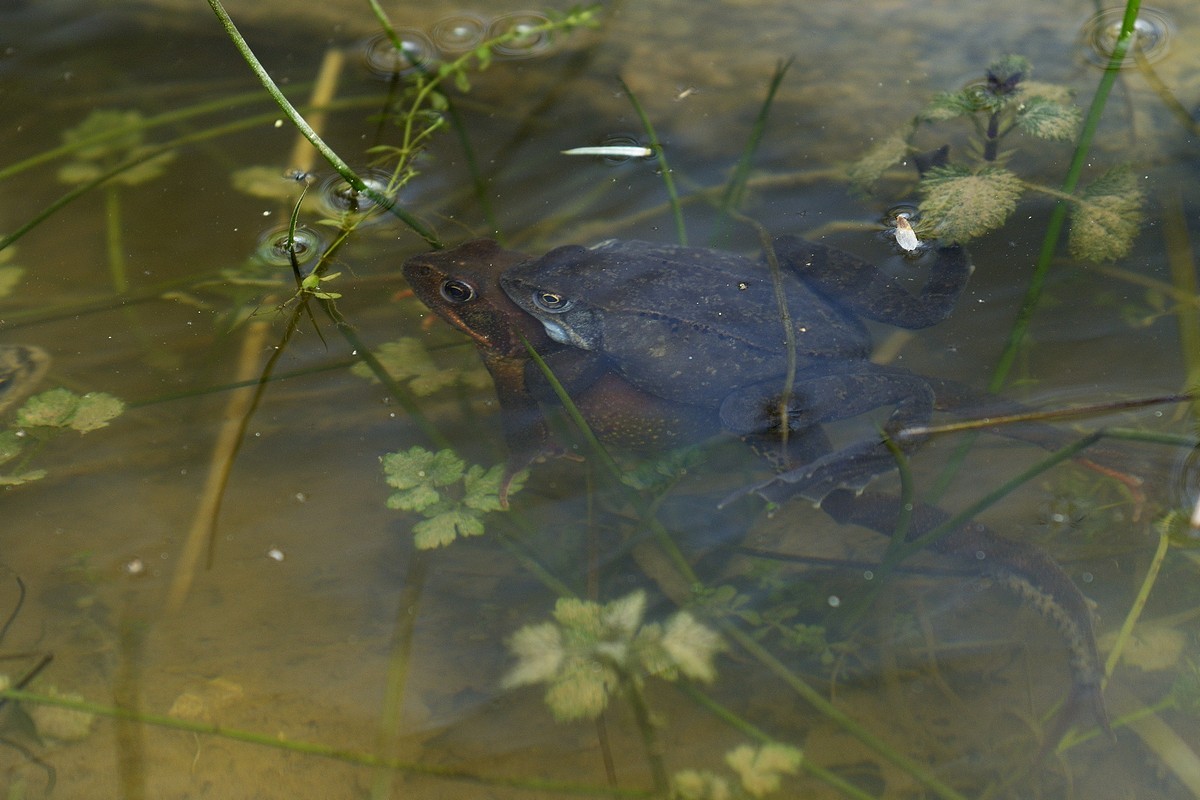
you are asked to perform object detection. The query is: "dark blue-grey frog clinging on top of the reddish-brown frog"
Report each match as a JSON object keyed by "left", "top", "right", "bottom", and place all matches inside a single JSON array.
[{"left": 500, "top": 236, "right": 972, "bottom": 503}]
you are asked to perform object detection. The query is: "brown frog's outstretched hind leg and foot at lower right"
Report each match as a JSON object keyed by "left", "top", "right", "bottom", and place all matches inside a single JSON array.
[{"left": 821, "top": 491, "right": 1112, "bottom": 751}]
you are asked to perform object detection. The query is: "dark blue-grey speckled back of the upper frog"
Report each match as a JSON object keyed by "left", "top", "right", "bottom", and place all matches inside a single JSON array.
[{"left": 530, "top": 240, "right": 869, "bottom": 402}]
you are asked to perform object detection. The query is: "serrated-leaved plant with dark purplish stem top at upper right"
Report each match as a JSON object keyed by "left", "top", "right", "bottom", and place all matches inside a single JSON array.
[{"left": 850, "top": 55, "right": 1142, "bottom": 261}]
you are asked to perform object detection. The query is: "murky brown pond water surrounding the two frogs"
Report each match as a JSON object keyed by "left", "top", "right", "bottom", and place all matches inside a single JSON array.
[{"left": 0, "top": 0, "right": 1200, "bottom": 798}]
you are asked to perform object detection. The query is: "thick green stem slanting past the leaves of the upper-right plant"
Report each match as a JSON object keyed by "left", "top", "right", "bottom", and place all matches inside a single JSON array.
[{"left": 988, "top": 0, "right": 1141, "bottom": 392}]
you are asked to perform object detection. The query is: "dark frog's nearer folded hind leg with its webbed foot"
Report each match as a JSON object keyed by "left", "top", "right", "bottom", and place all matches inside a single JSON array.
[{"left": 721, "top": 362, "right": 935, "bottom": 503}]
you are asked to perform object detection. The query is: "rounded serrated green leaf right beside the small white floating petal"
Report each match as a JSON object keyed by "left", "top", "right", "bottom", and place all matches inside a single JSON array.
[{"left": 920, "top": 167, "right": 1025, "bottom": 243}]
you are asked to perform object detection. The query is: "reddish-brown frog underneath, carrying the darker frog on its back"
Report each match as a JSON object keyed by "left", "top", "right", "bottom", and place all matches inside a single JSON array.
[{"left": 404, "top": 240, "right": 1108, "bottom": 743}]
